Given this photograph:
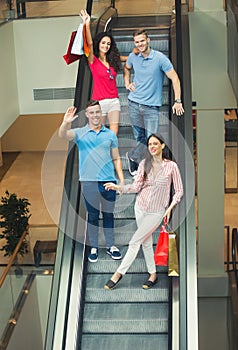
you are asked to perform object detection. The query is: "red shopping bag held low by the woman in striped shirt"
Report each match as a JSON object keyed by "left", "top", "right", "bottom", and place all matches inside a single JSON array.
[{"left": 154, "top": 221, "right": 169, "bottom": 266}]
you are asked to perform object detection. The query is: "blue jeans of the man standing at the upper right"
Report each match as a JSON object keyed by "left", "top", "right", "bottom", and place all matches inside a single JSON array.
[{"left": 128, "top": 100, "right": 159, "bottom": 164}]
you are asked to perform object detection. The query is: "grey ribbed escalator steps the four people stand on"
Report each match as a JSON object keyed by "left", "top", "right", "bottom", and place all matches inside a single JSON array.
[{"left": 78, "top": 18, "right": 171, "bottom": 350}]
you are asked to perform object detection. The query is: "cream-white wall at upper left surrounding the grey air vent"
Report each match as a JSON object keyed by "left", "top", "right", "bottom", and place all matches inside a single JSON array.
[{"left": 0, "top": 16, "right": 80, "bottom": 137}]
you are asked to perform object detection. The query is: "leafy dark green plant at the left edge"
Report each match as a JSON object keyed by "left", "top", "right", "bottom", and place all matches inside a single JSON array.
[{"left": 0, "top": 191, "right": 31, "bottom": 256}]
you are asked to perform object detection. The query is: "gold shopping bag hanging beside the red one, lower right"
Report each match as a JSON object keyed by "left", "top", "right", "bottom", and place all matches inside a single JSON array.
[{"left": 168, "top": 232, "right": 179, "bottom": 276}]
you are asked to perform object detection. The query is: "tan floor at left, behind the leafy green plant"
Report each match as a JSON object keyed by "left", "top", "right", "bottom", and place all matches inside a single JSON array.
[{"left": 0, "top": 152, "right": 66, "bottom": 263}]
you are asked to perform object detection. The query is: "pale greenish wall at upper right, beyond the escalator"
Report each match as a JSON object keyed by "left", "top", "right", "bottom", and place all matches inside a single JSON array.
[{"left": 189, "top": 11, "right": 236, "bottom": 109}]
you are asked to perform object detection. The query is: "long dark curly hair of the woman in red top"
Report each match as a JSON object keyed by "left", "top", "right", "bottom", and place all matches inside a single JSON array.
[{"left": 93, "top": 32, "right": 121, "bottom": 72}]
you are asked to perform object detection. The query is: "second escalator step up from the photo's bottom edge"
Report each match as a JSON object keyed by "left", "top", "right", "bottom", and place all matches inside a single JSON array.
[{"left": 83, "top": 303, "right": 168, "bottom": 334}]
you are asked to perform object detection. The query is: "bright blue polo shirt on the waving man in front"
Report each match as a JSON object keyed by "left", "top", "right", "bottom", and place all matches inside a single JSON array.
[{"left": 72, "top": 124, "right": 118, "bottom": 181}]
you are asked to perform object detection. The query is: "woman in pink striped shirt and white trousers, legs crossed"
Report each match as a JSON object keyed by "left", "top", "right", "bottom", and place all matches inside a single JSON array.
[{"left": 104, "top": 134, "right": 183, "bottom": 289}]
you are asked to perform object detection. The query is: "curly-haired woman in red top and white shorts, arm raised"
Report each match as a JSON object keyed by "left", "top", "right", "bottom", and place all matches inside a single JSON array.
[{"left": 80, "top": 10, "right": 126, "bottom": 135}]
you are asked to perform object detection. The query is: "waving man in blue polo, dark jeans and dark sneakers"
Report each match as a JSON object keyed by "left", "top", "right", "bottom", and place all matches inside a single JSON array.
[{"left": 59, "top": 101, "right": 124, "bottom": 262}]
